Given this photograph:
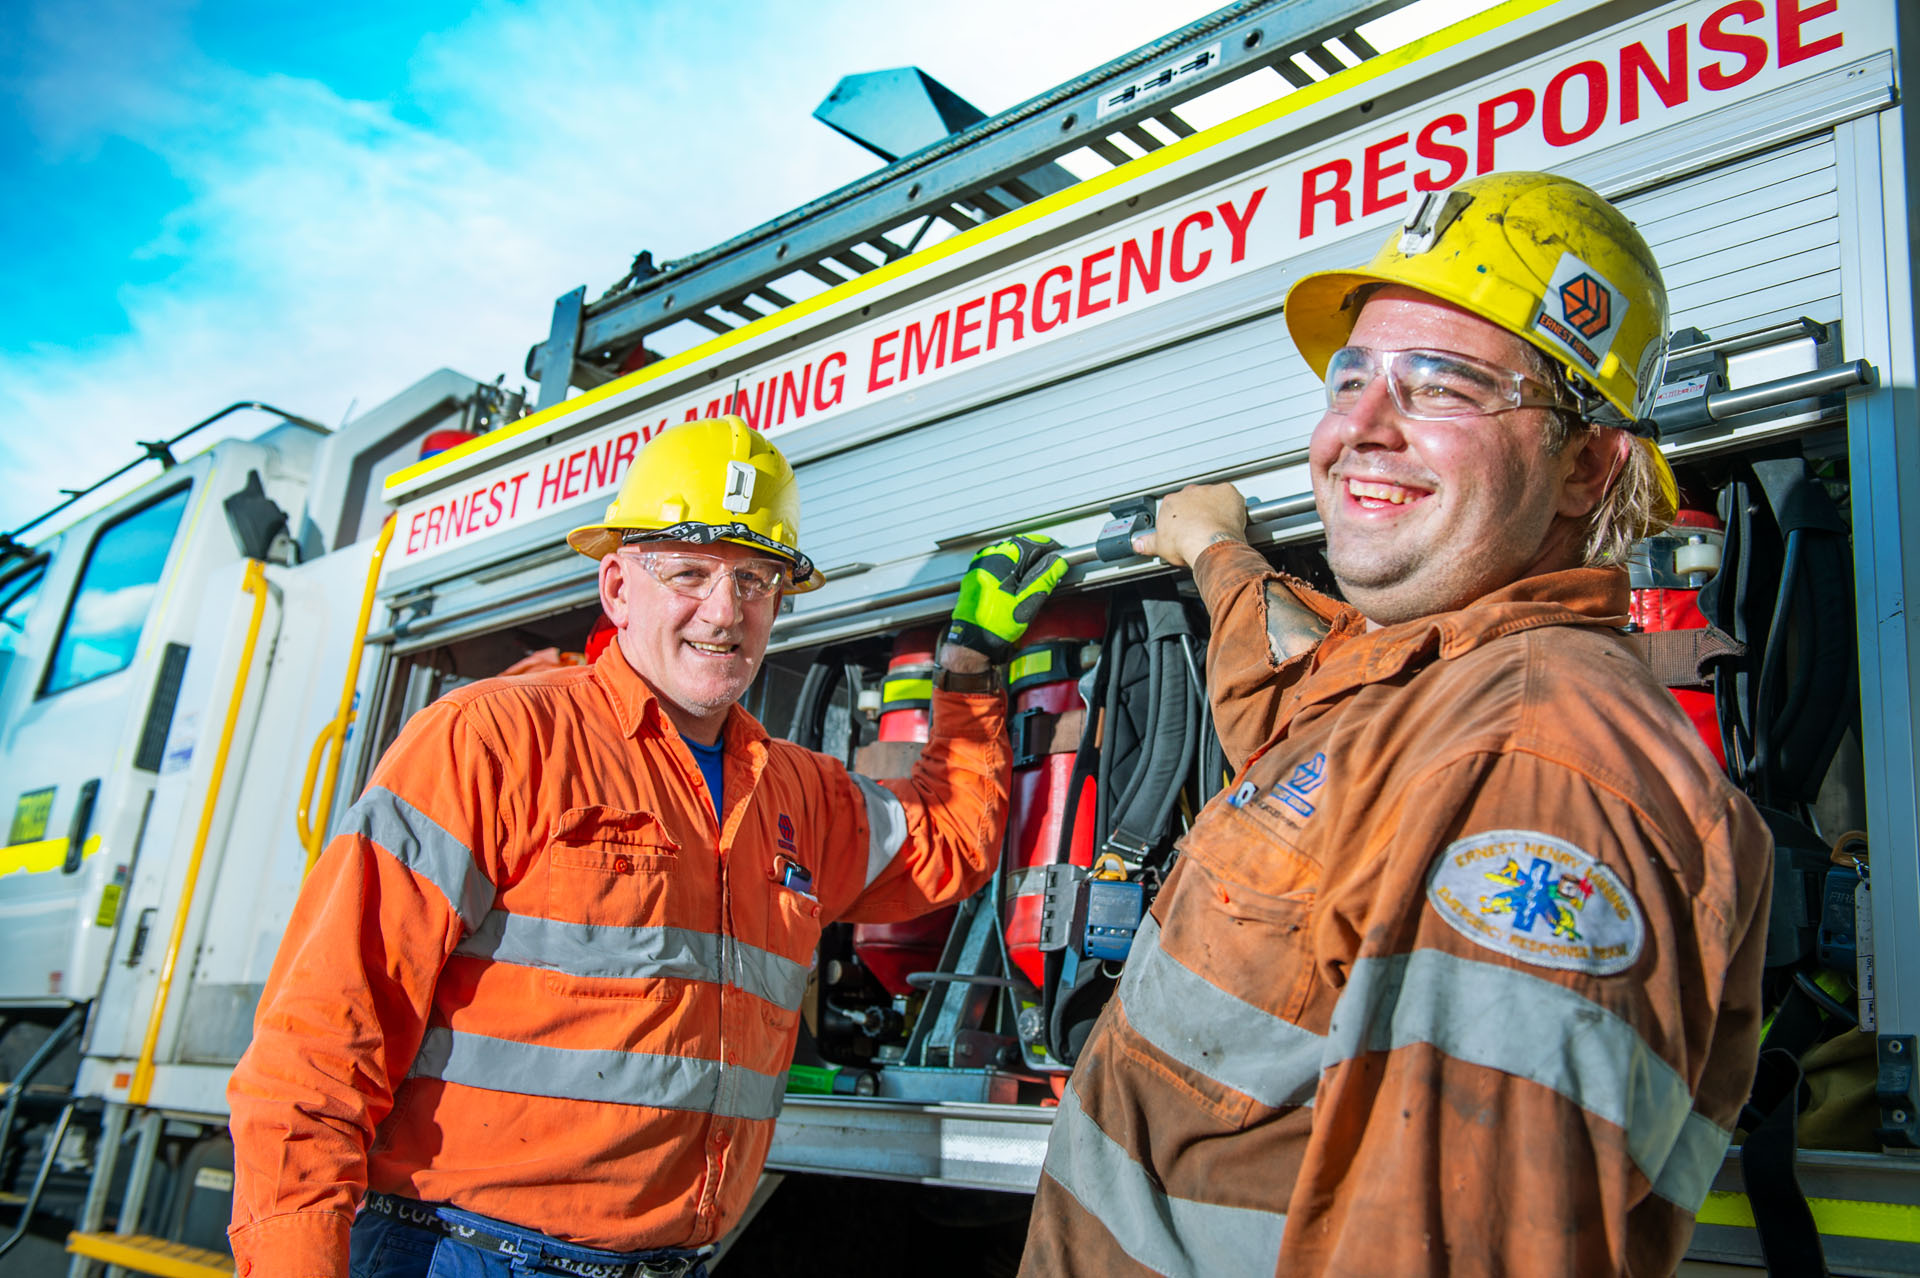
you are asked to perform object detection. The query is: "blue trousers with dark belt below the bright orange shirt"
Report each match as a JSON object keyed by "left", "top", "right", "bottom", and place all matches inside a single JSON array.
[{"left": 348, "top": 1203, "right": 707, "bottom": 1278}]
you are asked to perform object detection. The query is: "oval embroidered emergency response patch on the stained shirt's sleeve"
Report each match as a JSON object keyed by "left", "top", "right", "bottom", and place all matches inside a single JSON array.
[{"left": 1427, "top": 829, "right": 1647, "bottom": 977}]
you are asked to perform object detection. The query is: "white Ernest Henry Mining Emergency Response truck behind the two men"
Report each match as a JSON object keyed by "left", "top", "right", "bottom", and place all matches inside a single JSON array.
[{"left": 0, "top": 0, "right": 1920, "bottom": 1274}]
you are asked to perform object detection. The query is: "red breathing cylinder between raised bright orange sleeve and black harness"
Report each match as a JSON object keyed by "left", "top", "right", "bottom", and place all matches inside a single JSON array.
[{"left": 1000, "top": 595, "right": 1106, "bottom": 986}]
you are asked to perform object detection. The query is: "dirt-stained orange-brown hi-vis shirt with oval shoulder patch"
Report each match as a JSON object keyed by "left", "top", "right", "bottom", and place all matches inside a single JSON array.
[{"left": 1021, "top": 543, "right": 1772, "bottom": 1278}]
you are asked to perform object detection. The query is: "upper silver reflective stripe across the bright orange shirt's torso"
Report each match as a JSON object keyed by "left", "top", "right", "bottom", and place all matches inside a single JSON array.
[{"left": 455, "top": 910, "right": 806, "bottom": 1009}]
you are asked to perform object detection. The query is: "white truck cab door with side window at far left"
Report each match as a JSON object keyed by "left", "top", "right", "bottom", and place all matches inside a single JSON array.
[{"left": 0, "top": 443, "right": 291, "bottom": 1006}]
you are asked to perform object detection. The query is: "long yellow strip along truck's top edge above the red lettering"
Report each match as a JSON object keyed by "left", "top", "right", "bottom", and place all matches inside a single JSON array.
[{"left": 382, "top": 0, "right": 1559, "bottom": 495}]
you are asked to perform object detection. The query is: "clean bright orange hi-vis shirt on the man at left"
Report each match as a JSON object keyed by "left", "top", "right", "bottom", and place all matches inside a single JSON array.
[{"left": 228, "top": 645, "right": 1010, "bottom": 1278}]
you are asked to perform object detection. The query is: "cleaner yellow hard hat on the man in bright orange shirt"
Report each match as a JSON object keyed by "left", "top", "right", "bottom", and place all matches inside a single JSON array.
[{"left": 566, "top": 416, "right": 826, "bottom": 595}]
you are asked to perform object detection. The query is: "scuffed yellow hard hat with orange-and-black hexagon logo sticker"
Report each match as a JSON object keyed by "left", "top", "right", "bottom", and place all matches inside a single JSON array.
[{"left": 1286, "top": 173, "right": 1680, "bottom": 518}]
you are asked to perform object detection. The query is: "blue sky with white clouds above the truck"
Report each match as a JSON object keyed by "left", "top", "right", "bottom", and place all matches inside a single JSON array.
[{"left": 0, "top": 0, "right": 1443, "bottom": 530}]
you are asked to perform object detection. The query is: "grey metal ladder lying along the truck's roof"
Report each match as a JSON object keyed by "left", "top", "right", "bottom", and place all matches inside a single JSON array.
[{"left": 526, "top": 0, "right": 1405, "bottom": 409}]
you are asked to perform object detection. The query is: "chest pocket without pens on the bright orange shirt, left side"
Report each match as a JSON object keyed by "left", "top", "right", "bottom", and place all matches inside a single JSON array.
[{"left": 547, "top": 806, "right": 680, "bottom": 927}]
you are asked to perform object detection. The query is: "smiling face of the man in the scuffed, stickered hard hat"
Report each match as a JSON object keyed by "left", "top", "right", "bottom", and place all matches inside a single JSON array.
[{"left": 1309, "top": 286, "right": 1619, "bottom": 626}]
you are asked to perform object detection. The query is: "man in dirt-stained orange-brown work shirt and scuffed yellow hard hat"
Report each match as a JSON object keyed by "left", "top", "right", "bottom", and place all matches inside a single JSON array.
[{"left": 1023, "top": 173, "right": 1772, "bottom": 1278}]
